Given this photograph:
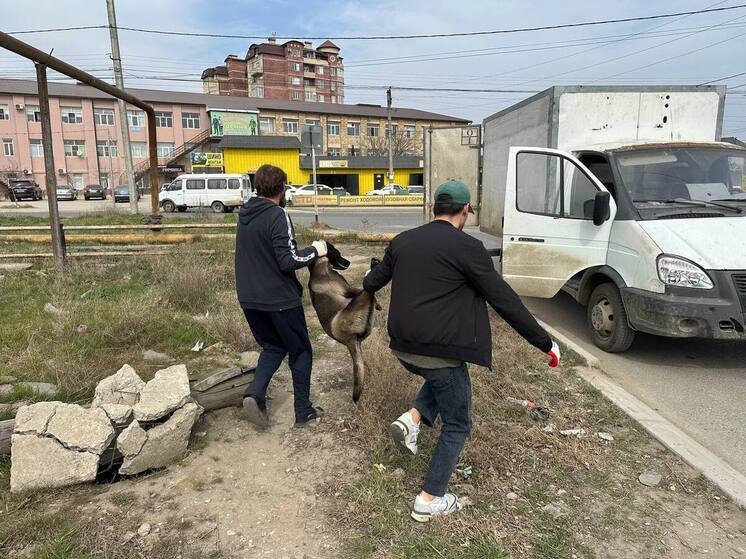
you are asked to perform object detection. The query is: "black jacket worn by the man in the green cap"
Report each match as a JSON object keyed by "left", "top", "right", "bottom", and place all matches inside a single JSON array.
[{"left": 363, "top": 220, "right": 552, "bottom": 367}]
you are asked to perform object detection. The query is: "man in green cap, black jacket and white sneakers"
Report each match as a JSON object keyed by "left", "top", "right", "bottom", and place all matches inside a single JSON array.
[{"left": 363, "top": 180, "right": 560, "bottom": 522}]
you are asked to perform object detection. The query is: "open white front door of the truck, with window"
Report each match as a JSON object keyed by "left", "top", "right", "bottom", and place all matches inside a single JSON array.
[{"left": 502, "top": 147, "right": 616, "bottom": 297}]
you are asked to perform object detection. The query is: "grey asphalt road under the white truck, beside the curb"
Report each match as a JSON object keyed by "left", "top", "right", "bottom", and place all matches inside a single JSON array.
[{"left": 526, "top": 293, "right": 746, "bottom": 480}]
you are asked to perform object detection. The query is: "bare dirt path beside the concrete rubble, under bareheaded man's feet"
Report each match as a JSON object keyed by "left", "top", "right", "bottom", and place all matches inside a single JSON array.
[{"left": 87, "top": 336, "right": 359, "bottom": 559}]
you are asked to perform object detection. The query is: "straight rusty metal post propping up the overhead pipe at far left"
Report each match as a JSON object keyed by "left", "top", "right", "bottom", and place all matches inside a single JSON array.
[{"left": 36, "top": 63, "right": 65, "bottom": 269}]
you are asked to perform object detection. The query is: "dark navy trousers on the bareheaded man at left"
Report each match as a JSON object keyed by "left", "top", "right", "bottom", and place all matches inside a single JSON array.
[{"left": 243, "top": 307, "right": 313, "bottom": 419}]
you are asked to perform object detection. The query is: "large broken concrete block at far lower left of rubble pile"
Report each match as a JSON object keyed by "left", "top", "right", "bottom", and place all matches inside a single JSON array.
[{"left": 10, "top": 434, "right": 99, "bottom": 492}]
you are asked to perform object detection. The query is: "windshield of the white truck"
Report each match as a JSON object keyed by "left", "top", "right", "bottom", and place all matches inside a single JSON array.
[{"left": 615, "top": 147, "right": 746, "bottom": 219}]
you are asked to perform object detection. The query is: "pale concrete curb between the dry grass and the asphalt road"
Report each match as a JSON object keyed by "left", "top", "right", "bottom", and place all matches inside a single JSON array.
[{"left": 539, "top": 321, "right": 746, "bottom": 509}]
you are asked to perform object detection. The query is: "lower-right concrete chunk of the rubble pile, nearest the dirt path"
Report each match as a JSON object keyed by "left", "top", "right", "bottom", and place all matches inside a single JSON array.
[{"left": 117, "top": 402, "right": 202, "bottom": 475}]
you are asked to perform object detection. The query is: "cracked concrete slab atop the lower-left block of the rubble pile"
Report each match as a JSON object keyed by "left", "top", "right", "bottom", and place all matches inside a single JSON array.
[{"left": 45, "top": 403, "right": 116, "bottom": 456}]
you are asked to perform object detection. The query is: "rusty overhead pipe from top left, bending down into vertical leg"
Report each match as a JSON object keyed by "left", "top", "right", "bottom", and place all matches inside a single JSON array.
[{"left": 0, "top": 31, "right": 160, "bottom": 223}]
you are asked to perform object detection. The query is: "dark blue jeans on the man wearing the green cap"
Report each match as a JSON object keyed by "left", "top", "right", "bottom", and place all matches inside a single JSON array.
[{"left": 401, "top": 361, "right": 471, "bottom": 497}]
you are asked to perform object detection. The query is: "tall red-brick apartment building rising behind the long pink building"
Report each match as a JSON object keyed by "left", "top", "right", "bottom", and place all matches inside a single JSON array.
[{"left": 202, "top": 37, "right": 344, "bottom": 104}]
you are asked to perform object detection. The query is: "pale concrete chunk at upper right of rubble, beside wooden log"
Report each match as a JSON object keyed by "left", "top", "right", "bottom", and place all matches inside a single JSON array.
[{"left": 134, "top": 365, "right": 190, "bottom": 421}]
